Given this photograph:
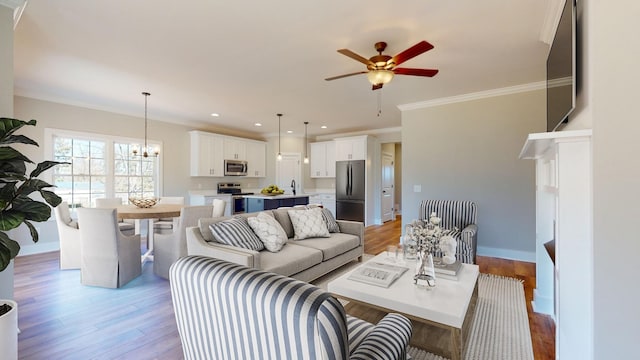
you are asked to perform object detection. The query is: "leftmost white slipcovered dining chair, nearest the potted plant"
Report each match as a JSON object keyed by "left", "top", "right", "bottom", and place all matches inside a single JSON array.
[{"left": 53, "top": 201, "right": 80, "bottom": 270}]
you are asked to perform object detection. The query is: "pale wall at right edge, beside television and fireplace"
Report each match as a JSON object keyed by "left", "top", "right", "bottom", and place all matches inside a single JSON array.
[{"left": 592, "top": 0, "right": 640, "bottom": 359}]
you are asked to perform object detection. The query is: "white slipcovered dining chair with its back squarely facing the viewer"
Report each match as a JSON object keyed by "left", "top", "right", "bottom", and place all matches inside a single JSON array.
[{"left": 78, "top": 208, "right": 142, "bottom": 288}]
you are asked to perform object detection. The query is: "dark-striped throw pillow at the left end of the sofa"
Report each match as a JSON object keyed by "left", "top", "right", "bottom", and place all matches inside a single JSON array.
[{"left": 209, "top": 217, "right": 264, "bottom": 251}]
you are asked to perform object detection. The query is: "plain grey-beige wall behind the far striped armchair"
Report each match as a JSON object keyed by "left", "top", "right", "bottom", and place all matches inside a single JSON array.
[{"left": 402, "top": 90, "right": 546, "bottom": 261}]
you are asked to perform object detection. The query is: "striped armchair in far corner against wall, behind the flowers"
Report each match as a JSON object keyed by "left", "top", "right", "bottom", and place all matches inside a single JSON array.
[{"left": 419, "top": 200, "right": 478, "bottom": 264}]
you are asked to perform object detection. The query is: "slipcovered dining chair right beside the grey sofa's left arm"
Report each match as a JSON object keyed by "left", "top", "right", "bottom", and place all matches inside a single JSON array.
[{"left": 153, "top": 205, "right": 215, "bottom": 279}]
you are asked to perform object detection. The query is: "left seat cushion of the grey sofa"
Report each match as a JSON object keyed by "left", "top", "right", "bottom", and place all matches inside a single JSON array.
[{"left": 260, "top": 242, "right": 322, "bottom": 276}]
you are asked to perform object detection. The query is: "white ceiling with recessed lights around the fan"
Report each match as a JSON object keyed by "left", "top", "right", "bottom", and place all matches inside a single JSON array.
[{"left": 14, "top": 0, "right": 552, "bottom": 135}]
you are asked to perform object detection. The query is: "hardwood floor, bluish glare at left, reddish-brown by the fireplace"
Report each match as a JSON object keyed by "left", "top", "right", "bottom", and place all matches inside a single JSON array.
[{"left": 15, "top": 215, "right": 555, "bottom": 360}]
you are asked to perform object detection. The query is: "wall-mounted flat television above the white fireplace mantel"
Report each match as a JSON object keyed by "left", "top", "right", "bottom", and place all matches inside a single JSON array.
[{"left": 547, "top": 0, "right": 576, "bottom": 131}]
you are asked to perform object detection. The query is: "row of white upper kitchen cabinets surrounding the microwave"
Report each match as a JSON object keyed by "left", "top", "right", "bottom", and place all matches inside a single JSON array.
[{"left": 190, "top": 131, "right": 267, "bottom": 177}]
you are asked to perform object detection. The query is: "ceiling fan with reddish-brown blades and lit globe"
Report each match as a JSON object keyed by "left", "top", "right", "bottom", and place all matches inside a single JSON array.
[{"left": 325, "top": 40, "right": 438, "bottom": 90}]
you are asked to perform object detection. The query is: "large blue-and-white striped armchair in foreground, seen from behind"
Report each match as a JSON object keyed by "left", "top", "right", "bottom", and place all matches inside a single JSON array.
[{"left": 170, "top": 256, "right": 411, "bottom": 360}]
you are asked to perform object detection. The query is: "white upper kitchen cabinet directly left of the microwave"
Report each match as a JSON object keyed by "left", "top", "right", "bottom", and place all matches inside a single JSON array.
[{"left": 189, "top": 131, "right": 224, "bottom": 177}]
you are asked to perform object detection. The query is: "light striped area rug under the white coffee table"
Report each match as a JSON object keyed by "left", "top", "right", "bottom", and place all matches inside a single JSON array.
[{"left": 314, "top": 255, "right": 533, "bottom": 360}]
